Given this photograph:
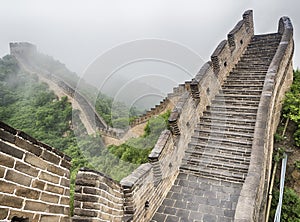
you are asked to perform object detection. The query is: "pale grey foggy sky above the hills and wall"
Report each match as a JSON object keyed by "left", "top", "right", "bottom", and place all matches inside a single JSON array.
[{"left": 0, "top": 0, "right": 300, "bottom": 106}]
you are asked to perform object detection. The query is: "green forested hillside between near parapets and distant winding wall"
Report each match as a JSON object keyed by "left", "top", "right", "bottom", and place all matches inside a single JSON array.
[{"left": 0, "top": 55, "right": 169, "bottom": 213}]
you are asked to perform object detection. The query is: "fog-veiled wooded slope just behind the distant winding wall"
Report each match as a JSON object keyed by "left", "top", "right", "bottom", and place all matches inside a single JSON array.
[{"left": 23, "top": 49, "right": 142, "bottom": 129}]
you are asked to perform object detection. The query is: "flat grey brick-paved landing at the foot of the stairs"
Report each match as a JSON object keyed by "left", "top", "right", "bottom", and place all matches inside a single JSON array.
[{"left": 152, "top": 173, "right": 242, "bottom": 222}]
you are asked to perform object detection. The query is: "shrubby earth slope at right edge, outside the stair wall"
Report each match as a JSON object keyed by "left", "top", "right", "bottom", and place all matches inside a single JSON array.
[{"left": 269, "top": 70, "right": 300, "bottom": 222}]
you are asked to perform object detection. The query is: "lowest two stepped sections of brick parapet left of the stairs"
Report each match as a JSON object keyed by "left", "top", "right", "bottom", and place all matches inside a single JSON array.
[{"left": 120, "top": 130, "right": 180, "bottom": 221}]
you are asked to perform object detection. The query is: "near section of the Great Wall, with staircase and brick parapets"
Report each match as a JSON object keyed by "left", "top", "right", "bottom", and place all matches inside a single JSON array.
[{"left": 0, "top": 10, "right": 294, "bottom": 222}]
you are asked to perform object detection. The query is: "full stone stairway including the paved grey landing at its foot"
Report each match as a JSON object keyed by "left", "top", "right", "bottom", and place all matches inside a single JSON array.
[{"left": 152, "top": 33, "right": 281, "bottom": 222}]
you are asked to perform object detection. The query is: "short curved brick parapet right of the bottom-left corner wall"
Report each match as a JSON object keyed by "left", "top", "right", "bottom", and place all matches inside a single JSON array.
[{"left": 72, "top": 168, "right": 124, "bottom": 222}]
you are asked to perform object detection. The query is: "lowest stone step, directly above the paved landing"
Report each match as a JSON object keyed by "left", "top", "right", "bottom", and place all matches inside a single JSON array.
[{"left": 180, "top": 165, "right": 246, "bottom": 183}]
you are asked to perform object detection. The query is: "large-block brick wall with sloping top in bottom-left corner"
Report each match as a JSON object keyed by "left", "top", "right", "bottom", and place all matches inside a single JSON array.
[{"left": 0, "top": 122, "right": 71, "bottom": 222}]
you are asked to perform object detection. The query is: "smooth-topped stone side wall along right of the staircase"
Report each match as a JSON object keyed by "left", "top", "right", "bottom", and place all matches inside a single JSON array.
[{"left": 235, "top": 17, "right": 294, "bottom": 221}]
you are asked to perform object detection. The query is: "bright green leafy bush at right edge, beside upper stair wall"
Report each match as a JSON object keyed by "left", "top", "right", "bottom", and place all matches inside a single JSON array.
[{"left": 283, "top": 70, "right": 300, "bottom": 147}]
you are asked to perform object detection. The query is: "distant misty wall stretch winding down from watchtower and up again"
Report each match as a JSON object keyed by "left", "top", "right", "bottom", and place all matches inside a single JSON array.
[{"left": 10, "top": 42, "right": 186, "bottom": 144}]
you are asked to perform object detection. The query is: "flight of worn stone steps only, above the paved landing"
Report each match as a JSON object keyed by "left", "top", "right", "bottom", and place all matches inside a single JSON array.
[{"left": 181, "top": 34, "right": 280, "bottom": 183}]
